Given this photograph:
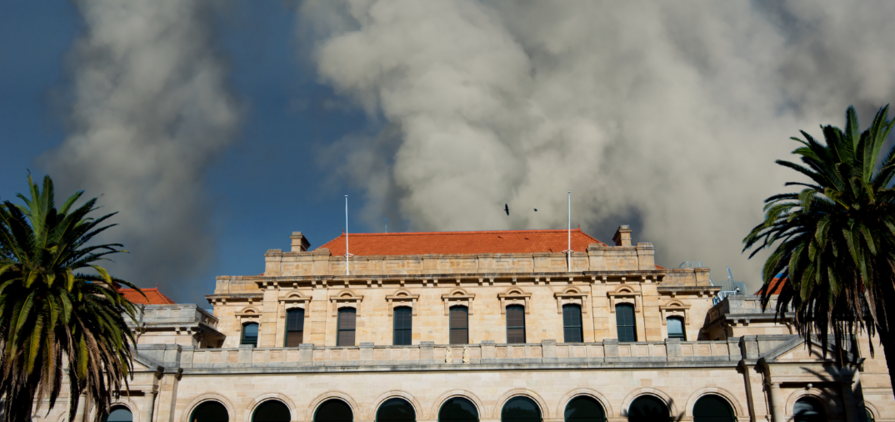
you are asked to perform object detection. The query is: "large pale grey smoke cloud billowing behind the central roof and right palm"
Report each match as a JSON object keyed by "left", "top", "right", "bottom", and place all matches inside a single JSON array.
[{"left": 298, "top": 0, "right": 895, "bottom": 288}]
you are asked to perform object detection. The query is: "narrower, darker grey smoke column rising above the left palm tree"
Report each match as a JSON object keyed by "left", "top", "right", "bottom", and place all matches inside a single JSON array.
[{"left": 42, "top": 0, "right": 242, "bottom": 300}]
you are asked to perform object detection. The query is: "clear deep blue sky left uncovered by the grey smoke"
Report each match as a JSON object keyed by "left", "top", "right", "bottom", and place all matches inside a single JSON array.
[{"left": 0, "top": 0, "right": 371, "bottom": 301}]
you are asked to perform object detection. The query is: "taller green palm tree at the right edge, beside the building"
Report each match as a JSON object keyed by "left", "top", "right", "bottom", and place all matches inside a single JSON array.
[{"left": 743, "top": 106, "right": 895, "bottom": 392}]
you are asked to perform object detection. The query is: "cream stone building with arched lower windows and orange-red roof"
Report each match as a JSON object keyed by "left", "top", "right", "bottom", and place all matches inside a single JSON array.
[{"left": 31, "top": 226, "right": 895, "bottom": 422}]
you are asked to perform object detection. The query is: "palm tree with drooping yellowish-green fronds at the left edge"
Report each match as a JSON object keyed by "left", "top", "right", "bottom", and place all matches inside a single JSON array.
[{"left": 0, "top": 175, "right": 137, "bottom": 422}]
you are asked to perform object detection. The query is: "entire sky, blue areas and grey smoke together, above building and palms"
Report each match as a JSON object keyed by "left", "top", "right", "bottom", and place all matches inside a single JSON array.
[{"left": 0, "top": 0, "right": 895, "bottom": 304}]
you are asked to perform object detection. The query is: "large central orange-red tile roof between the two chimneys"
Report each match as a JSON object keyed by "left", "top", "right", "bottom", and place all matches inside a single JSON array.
[{"left": 318, "top": 229, "right": 605, "bottom": 256}]
